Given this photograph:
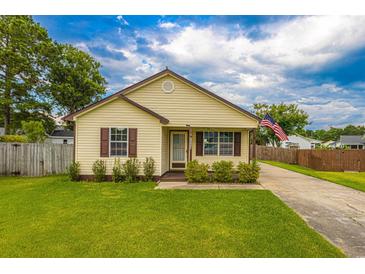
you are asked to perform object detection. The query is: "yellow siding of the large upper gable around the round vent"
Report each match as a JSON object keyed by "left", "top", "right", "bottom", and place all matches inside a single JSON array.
[{"left": 126, "top": 75, "right": 257, "bottom": 128}]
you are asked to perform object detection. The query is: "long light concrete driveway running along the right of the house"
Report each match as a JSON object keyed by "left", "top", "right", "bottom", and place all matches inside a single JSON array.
[{"left": 259, "top": 163, "right": 365, "bottom": 257}]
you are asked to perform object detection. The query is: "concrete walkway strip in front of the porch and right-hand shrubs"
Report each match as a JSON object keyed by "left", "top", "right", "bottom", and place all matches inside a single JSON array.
[{"left": 155, "top": 182, "right": 263, "bottom": 189}]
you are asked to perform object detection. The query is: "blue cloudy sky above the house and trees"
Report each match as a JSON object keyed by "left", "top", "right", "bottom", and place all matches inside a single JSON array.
[{"left": 34, "top": 15, "right": 365, "bottom": 129}]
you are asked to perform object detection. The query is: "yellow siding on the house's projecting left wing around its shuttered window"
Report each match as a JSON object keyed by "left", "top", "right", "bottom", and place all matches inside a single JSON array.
[{"left": 75, "top": 98, "right": 161, "bottom": 175}]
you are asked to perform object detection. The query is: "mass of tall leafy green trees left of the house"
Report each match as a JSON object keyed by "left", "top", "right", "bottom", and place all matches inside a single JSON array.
[{"left": 0, "top": 16, "right": 105, "bottom": 134}]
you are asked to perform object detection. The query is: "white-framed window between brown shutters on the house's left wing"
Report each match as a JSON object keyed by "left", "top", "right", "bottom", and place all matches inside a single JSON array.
[{"left": 110, "top": 128, "right": 128, "bottom": 156}]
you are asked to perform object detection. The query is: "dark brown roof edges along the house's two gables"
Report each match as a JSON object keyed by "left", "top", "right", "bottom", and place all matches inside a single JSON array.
[{"left": 62, "top": 67, "right": 261, "bottom": 123}]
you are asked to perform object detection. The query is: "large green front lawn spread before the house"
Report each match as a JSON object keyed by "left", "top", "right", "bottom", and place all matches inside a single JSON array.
[{"left": 0, "top": 176, "right": 344, "bottom": 257}]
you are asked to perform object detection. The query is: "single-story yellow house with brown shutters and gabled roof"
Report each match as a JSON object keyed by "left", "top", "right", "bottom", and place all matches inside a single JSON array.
[{"left": 63, "top": 68, "right": 259, "bottom": 179}]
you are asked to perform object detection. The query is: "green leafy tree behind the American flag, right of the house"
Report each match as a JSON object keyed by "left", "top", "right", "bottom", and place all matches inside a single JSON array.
[{"left": 254, "top": 103, "right": 309, "bottom": 146}]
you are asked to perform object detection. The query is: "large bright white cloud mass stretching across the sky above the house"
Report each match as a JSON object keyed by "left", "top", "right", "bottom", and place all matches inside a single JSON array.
[{"left": 74, "top": 16, "right": 365, "bottom": 128}]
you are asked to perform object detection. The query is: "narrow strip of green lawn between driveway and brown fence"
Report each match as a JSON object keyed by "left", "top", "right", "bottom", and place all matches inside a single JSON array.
[{"left": 260, "top": 160, "right": 365, "bottom": 191}]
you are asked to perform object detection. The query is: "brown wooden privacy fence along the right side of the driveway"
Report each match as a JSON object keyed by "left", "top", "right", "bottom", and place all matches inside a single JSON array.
[{"left": 256, "top": 143, "right": 365, "bottom": 171}]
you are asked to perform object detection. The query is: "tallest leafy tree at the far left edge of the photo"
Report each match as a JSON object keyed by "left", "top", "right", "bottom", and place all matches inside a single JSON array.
[{"left": 0, "top": 16, "right": 52, "bottom": 134}]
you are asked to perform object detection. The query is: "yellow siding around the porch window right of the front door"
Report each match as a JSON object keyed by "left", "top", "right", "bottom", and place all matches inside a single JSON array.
[{"left": 192, "top": 128, "right": 249, "bottom": 166}]
